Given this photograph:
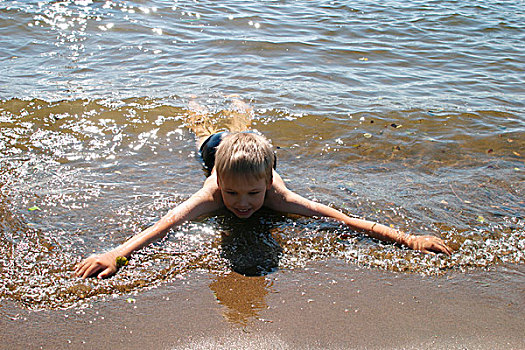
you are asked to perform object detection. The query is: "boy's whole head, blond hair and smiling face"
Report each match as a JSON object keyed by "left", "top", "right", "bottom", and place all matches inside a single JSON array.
[{"left": 215, "top": 132, "right": 275, "bottom": 218}]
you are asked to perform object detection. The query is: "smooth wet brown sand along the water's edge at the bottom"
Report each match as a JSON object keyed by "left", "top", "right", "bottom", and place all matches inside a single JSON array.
[{"left": 0, "top": 261, "right": 525, "bottom": 349}]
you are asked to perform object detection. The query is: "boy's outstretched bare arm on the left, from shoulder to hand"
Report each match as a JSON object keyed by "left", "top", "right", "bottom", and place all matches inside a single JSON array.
[{"left": 75, "top": 175, "right": 222, "bottom": 278}]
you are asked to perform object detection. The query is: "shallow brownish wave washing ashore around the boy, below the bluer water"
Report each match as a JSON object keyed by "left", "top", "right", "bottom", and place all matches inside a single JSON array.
[{"left": 0, "top": 96, "right": 525, "bottom": 309}]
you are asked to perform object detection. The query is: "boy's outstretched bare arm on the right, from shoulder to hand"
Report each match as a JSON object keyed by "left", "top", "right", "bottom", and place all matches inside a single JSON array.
[{"left": 265, "top": 171, "right": 452, "bottom": 255}]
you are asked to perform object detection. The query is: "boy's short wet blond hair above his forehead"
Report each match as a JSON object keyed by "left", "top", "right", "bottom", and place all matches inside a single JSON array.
[{"left": 215, "top": 132, "right": 275, "bottom": 183}]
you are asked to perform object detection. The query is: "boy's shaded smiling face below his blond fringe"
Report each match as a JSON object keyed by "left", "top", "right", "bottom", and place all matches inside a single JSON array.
[{"left": 217, "top": 175, "right": 270, "bottom": 219}]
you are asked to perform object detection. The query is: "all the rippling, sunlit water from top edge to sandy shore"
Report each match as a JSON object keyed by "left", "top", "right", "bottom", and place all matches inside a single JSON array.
[{"left": 0, "top": 0, "right": 525, "bottom": 309}]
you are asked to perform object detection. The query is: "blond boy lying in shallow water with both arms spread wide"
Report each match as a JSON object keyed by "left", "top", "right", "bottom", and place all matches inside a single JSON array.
[{"left": 75, "top": 100, "right": 452, "bottom": 278}]
